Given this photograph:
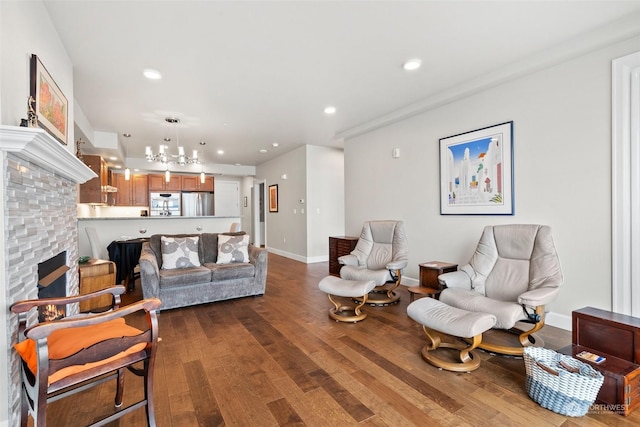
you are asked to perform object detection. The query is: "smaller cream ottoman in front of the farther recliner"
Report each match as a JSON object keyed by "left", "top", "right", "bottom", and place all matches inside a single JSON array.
[{"left": 318, "top": 276, "right": 376, "bottom": 323}]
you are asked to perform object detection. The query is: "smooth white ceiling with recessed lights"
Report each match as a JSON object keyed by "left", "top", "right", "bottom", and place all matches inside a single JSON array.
[{"left": 44, "top": 0, "right": 640, "bottom": 172}]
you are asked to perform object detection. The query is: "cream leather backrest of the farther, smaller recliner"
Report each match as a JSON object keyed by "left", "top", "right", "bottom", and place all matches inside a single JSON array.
[{"left": 351, "top": 221, "right": 408, "bottom": 270}]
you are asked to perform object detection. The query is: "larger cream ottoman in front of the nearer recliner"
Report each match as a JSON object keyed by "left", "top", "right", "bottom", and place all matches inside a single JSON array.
[{"left": 407, "top": 298, "right": 496, "bottom": 372}]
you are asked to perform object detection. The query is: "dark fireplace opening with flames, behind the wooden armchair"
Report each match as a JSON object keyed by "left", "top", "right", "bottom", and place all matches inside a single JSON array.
[{"left": 38, "top": 251, "right": 70, "bottom": 322}]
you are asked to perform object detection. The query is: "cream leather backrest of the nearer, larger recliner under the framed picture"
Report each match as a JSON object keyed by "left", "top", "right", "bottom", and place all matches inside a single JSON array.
[{"left": 464, "top": 224, "right": 562, "bottom": 301}]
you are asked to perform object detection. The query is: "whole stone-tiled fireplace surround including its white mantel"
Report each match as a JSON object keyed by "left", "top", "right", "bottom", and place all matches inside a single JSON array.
[{"left": 0, "top": 126, "right": 95, "bottom": 425}]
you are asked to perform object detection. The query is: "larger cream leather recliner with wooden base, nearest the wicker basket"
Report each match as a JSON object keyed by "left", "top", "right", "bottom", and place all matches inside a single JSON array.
[{"left": 438, "top": 224, "right": 563, "bottom": 355}]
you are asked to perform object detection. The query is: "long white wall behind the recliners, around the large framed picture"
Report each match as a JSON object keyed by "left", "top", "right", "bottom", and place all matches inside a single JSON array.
[{"left": 345, "top": 38, "right": 640, "bottom": 325}]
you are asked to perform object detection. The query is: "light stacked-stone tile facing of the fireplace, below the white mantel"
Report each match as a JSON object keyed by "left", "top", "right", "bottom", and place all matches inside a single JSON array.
[{"left": 3, "top": 154, "right": 78, "bottom": 425}]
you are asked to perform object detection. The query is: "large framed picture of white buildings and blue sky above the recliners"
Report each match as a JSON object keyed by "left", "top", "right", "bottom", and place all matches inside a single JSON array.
[{"left": 440, "top": 121, "right": 514, "bottom": 215}]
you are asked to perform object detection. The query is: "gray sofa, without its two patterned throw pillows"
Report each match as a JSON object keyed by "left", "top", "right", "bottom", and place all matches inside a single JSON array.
[{"left": 140, "top": 232, "right": 267, "bottom": 309}]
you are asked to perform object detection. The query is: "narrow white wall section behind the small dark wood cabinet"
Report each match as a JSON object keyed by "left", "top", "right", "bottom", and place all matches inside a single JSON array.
[{"left": 306, "top": 145, "right": 344, "bottom": 262}]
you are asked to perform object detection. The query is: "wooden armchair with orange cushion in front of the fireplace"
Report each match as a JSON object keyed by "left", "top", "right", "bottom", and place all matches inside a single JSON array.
[{"left": 11, "top": 286, "right": 161, "bottom": 427}]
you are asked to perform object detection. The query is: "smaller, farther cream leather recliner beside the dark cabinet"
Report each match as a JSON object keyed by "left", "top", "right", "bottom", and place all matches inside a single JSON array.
[{"left": 338, "top": 221, "right": 409, "bottom": 305}]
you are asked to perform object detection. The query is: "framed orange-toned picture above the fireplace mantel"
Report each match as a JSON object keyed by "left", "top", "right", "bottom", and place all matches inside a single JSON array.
[{"left": 29, "top": 55, "right": 69, "bottom": 145}]
